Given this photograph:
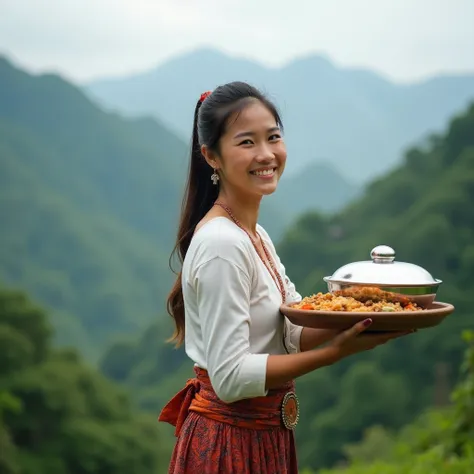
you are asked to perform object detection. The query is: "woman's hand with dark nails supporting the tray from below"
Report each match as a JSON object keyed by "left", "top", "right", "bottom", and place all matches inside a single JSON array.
[{"left": 329, "top": 318, "right": 413, "bottom": 359}]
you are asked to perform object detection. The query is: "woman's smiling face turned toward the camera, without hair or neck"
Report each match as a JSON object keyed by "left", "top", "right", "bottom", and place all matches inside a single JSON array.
[{"left": 203, "top": 101, "right": 286, "bottom": 198}]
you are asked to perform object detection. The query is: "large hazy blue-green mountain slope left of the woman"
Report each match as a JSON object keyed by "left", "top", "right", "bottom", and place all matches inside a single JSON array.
[{"left": 0, "top": 55, "right": 186, "bottom": 355}]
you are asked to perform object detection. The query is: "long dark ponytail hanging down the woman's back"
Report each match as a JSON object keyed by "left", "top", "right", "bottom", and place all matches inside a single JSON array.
[{"left": 167, "top": 100, "right": 219, "bottom": 347}]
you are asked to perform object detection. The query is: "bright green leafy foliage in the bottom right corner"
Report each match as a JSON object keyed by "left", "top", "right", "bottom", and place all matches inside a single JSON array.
[{"left": 312, "top": 332, "right": 474, "bottom": 474}]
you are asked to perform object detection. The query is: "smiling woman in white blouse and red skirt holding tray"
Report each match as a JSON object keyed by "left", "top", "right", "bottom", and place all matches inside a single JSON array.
[{"left": 159, "top": 82, "right": 408, "bottom": 474}]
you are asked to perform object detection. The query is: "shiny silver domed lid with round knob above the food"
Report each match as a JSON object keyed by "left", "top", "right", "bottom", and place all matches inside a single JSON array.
[{"left": 324, "top": 245, "right": 441, "bottom": 286}]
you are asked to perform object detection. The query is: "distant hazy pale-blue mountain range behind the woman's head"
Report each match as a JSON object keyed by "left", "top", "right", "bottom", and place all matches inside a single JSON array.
[{"left": 84, "top": 49, "right": 474, "bottom": 182}]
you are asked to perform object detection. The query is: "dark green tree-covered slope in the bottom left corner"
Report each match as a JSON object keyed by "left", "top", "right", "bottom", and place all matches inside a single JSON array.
[{"left": 0, "top": 290, "right": 167, "bottom": 474}]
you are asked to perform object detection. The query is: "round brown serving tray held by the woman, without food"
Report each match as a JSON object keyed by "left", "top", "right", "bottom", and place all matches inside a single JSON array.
[{"left": 280, "top": 301, "right": 454, "bottom": 332}]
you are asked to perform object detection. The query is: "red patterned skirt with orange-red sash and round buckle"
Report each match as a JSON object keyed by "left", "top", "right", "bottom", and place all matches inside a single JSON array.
[{"left": 158, "top": 368, "right": 298, "bottom": 474}]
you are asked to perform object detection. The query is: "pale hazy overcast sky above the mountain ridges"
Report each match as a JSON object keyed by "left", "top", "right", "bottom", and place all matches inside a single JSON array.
[{"left": 0, "top": 0, "right": 474, "bottom": 81}]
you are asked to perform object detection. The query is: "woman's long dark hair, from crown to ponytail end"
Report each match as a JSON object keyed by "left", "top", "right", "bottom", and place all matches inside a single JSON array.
[{"left": 167, "top": 82, "right": 283, "bottom": 346}]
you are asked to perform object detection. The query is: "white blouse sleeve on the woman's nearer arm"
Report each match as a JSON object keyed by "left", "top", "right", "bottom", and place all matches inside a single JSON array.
[{"left": 195, "top": 252, "right": 268, "bottom": 403}]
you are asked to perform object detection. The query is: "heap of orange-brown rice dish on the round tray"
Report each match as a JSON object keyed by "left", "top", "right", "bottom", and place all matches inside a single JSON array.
[{"left": 292, "top": 287, "right": 423, "bottom": 313}]
